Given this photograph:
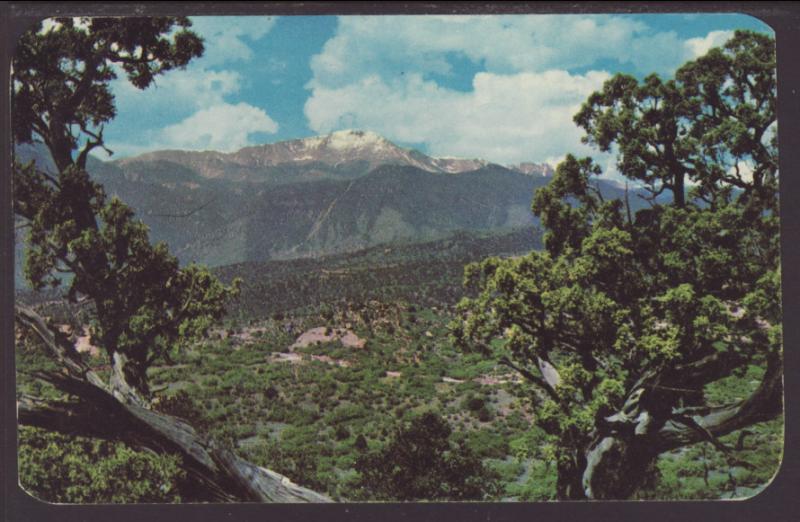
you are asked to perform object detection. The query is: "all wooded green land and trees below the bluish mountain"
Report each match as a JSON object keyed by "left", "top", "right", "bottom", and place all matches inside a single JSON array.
[{"left": 12, "top": 17, "right": 783, "bottom": 503}]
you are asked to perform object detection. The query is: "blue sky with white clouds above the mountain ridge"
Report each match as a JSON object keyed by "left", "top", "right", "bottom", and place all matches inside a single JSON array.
[{"left": 98, "top": 14, "right": 772, "bottom": 169}]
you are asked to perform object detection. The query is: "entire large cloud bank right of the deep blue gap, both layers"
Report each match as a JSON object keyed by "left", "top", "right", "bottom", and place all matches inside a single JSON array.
[{"left": 305, "top": 15, "right": 740, "bottom": 168}]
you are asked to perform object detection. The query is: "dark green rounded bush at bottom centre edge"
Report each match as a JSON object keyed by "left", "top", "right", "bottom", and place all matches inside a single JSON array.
[{"left": 355, "top": 413, "right": 498, "bottom": 501}]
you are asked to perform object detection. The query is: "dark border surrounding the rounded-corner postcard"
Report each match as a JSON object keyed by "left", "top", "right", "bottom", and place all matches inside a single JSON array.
[{"left": 0, "top": 2, "right": 800, "bottom": 522}]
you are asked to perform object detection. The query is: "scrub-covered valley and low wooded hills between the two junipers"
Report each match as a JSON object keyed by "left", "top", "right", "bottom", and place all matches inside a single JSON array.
[{"left": 17, "top": 220, "right": 782, "bottom": 501}]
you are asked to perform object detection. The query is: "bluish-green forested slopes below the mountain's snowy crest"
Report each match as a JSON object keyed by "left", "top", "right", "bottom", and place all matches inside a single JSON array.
[{"left": 90, "top": 161, "right": 546, "bottom": 265}]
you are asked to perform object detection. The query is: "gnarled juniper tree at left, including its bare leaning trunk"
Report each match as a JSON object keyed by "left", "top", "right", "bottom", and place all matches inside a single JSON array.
[{"left": 12, "top": 17, "right": 329, "bottom": 502}]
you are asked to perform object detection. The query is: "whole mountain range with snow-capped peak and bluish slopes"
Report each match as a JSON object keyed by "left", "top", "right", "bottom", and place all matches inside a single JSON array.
[{"left": 10, "top": 131, "right": 639, "bottom": 273}]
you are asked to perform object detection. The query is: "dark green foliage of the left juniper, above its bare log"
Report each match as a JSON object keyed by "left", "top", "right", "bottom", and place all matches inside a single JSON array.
[{"left": 13, "top": 17, "right": 237, "bottom": 396}]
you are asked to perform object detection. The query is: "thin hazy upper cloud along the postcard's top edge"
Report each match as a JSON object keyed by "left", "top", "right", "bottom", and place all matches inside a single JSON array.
[{"left": 311, "top": 15, "right": 712, "bottom": 86}]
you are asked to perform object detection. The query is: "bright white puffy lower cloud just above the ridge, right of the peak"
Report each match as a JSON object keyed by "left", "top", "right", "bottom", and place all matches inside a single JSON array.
[{"left": 305, "top": 70, "right": 608, "bottom": 163}]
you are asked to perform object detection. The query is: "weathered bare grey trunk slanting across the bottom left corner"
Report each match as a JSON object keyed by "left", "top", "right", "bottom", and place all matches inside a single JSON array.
[{"left": 15, "top": 305, "right": 331, "bottom": 502}]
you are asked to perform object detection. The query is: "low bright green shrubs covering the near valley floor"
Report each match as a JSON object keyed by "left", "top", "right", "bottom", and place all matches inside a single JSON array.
[{"left": 17, "top": 292, "right": 781, "bottom": 501}]
